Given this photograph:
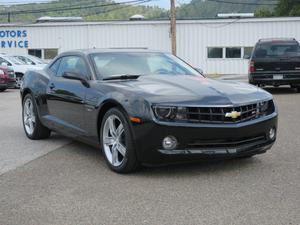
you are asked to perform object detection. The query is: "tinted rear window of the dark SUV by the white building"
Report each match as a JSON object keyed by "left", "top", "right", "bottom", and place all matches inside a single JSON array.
[{"left": 253, "top": 42, "right": 299, "bottom": 58}]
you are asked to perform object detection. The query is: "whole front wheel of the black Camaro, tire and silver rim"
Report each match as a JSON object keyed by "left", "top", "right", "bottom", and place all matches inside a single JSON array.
[{"left": 100, "top": 108, "right": 139, "bottom": 173}]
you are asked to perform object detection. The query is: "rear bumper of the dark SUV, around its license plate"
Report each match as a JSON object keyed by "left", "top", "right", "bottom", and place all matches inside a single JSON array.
[{"left": 249, "top": 72, "right": 300, "bottom": 85}]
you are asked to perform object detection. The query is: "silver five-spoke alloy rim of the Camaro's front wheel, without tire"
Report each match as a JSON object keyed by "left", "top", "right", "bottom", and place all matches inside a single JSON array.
[{"left": 102, "top": 114, "right": 127, "bottom": 167}]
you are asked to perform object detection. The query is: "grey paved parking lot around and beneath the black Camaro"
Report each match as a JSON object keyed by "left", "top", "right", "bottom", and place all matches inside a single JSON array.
[{"left": 0, "top": 88, "right": 300, "bottom": 225}]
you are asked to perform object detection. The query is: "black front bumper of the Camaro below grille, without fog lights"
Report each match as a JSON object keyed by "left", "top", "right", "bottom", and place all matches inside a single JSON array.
[{"left": 133, "top": 112, "right": 277, "bottom": 165}]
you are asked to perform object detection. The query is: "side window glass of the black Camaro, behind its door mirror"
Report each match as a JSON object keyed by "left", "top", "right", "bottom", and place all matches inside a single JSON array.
[{"left": 56, "top": 56, "right": 89, "bottom": 77}]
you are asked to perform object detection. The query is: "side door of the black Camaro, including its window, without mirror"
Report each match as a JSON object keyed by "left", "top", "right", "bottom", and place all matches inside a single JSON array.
[{"left": 47, "top": 55, "right": 90, "bottom": 136}]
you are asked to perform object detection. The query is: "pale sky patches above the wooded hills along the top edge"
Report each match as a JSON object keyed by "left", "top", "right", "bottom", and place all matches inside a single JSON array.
[{"left": 0, "top": 0, "right": 191, "bottom": 9}]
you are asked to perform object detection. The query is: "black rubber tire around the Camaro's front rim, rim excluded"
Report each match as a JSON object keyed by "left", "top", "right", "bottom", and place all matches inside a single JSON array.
[{"left": 100, "top": 108, "right": 140, "bottom": 173}]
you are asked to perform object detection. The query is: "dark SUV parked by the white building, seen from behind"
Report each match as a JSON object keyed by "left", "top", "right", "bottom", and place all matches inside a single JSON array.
[{"left": 249, "top": 38, "right": 300, "bottom": 91}]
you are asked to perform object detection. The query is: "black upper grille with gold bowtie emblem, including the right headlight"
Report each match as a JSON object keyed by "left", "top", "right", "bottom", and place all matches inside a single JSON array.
[{"left": 175, "top": 100, "right": 275, "bottom": 123}]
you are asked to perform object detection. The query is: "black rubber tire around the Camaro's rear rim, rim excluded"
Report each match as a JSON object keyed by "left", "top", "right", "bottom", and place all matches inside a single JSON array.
[{"left": 22, "top": 94, "right": 51, "bottom": 140}]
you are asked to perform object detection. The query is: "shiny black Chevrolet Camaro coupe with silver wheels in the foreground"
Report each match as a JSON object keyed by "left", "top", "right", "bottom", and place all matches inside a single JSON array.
[{"left": 21, "top": 49, "right": 277, "bottom": 173}]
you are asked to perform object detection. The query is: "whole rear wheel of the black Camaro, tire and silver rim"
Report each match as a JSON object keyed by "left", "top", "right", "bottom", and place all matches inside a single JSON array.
[{"left": 22, "top": 94, "right": 51, "bottom": 140}]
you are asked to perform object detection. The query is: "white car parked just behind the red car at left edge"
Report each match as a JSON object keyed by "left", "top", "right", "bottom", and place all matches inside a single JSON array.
[{"left": 0, "top": 54, "right": 41, "bottom": 88}]
